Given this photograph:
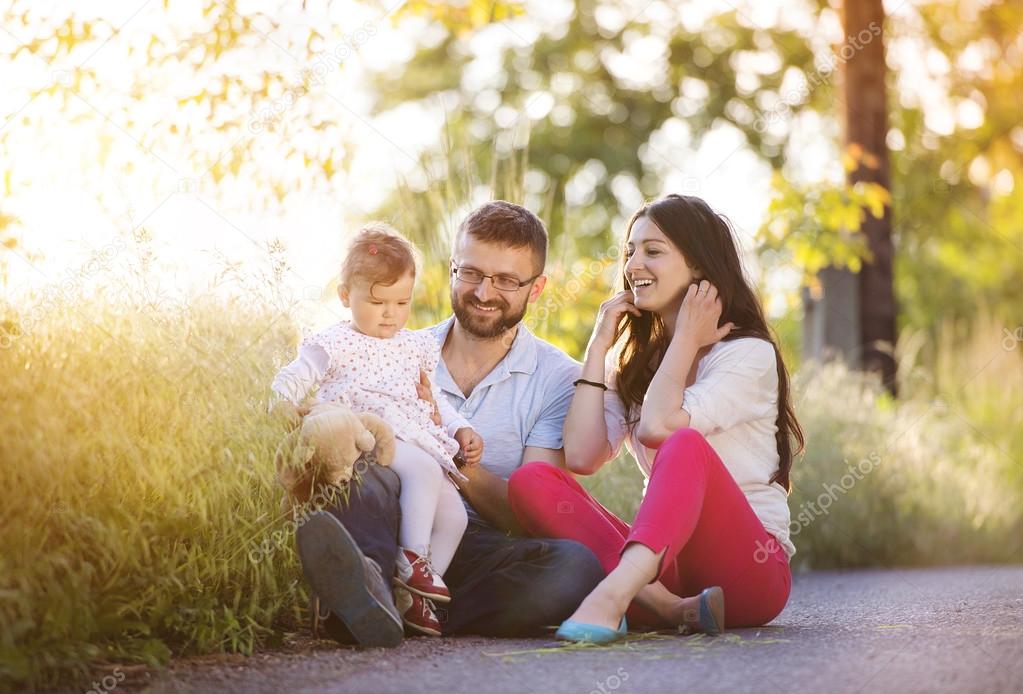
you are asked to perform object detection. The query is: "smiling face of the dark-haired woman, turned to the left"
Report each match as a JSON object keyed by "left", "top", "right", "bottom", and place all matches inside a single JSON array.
[{"left": 625, "top": 217, "right": 699, "bottom": 313}]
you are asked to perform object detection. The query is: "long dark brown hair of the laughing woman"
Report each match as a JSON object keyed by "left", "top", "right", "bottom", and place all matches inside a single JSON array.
[{"left": 615, "top": 194, "right": 805, "bottom": 490}]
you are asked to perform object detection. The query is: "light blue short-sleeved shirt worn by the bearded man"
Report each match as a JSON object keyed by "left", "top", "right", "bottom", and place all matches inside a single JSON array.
[{"left": 430, "top": 316, "right": 581, "bottom": 518}]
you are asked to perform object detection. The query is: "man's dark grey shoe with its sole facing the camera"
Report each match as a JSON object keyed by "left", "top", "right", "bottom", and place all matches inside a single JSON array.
[{"left": 296, "top": 511, "right": 404, "bottom": 647}]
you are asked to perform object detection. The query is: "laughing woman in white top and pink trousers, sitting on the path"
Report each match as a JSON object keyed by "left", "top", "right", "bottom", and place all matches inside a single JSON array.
[{"left": 509, "top": 194, "right": 803, "bottom": 643}]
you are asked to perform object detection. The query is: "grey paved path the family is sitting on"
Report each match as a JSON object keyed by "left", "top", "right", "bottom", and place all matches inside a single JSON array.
[{"left": 129, "top": 566, "right": 1023, "bottom": 694}]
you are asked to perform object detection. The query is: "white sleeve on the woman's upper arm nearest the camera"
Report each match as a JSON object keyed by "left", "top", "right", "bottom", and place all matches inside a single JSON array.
[{"left": 682, "top": 338, "right": 777, "bottom": 436}]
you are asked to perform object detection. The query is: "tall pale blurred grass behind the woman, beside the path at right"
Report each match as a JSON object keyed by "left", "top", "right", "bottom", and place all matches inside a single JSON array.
[{"left": 583, "top": 356, "right": 1023, "bottom": 568}]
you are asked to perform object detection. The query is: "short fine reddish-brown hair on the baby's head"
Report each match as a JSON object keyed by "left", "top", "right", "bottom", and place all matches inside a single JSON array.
[{"left": 341, "top": 222, "right": 418, "bottom": 288}]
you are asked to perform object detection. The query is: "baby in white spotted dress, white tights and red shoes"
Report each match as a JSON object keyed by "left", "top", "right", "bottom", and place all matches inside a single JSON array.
[{"left": 272, "top": 222, "right": 483, "bottom": 636}]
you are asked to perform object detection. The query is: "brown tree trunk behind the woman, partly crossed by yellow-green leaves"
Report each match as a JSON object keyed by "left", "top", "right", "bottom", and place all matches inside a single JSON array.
[{"left": 839, "top": 0, "right": 895, "bottom": 394}]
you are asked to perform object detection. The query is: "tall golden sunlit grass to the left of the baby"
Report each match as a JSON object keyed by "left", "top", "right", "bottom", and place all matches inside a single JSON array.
[{"left": 0, "top": 292, "right": 302, "bottom": 684}]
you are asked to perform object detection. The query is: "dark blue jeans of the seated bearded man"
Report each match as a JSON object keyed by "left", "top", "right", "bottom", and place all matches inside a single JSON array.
[{"left": 313, "top": 465, "right": 605, "bottom": 637}]
